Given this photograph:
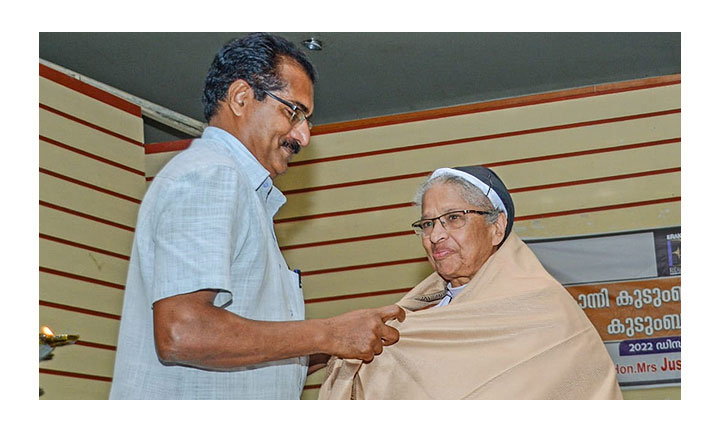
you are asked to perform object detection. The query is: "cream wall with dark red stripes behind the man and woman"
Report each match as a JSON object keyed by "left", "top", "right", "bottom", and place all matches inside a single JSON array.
[{"left": 125, "top": 72, "right": 682, "bottom": 399}]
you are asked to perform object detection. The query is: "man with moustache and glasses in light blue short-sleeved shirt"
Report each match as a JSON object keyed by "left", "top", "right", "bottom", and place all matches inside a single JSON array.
[{"left": 110, "top": 34, "right": 404, "bottom": 399}]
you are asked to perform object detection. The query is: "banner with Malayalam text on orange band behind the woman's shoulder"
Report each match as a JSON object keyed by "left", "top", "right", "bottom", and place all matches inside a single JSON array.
[{"left": 526, "top": 227, "right": 682, "bottom": 388}]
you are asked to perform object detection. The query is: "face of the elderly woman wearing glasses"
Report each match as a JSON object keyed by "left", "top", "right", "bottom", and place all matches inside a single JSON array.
[{"left": 421, "top": 183, "right": 507, "bottom": 287}]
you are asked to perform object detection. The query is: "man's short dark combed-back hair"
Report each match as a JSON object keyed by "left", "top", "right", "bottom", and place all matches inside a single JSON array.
[{"left": 202, "top": 33, "right": 316, "bottom": 121}]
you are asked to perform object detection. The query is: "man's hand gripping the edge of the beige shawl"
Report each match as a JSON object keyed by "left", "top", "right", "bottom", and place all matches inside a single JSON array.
[{"left": 323, "top": 305, "right": 405, "bottom": 362}]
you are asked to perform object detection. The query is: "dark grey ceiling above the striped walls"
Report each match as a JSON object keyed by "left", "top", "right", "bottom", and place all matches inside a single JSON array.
[{"left": 39, "top": 32, "right": 680, "bottom": 143}]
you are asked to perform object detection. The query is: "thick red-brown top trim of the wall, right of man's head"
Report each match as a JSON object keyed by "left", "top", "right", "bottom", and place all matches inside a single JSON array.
[{"left": 313, "top": 74, "right": 681, "bottom": 135}]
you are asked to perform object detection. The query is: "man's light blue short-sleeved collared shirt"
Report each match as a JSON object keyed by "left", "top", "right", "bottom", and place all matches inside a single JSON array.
[{"left": 110, "top": 127, "right": 307, "bottom": 399}]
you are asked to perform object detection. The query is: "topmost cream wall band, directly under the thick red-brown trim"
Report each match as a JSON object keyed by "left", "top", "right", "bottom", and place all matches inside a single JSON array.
[{"left": 279, "top": 81, "right": 680, "bottom": 167}]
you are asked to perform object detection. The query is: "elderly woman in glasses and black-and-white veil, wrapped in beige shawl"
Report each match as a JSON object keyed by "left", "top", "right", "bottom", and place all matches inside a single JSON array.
[{"left": 320, "top": 166, "right": 622, "bottom": 399}]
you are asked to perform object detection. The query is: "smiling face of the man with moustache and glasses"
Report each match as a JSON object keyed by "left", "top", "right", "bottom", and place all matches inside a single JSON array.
[{"left": 243, "top": 60, "right": 313, "bottom": 179}]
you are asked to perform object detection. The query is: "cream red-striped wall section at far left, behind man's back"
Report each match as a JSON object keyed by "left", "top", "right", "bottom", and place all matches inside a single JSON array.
[{"left": 38, "top": 65, "right": 145, "bottom": 399}]
